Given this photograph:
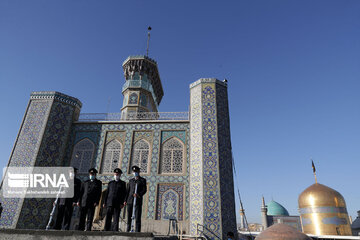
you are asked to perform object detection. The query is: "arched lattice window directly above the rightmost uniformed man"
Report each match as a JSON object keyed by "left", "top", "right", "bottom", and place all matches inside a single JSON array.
[{"left": 130, "top": 139, "right": 150, "bottom": 173}]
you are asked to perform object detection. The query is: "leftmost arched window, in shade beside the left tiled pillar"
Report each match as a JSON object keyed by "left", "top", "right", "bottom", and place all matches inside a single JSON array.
[{"left": 71, "top": 138, "right": 95, "bottom": 173}]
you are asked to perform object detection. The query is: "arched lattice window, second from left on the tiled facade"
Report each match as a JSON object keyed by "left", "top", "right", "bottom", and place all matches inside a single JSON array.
[{"left": 101, "top": 139, "right": 122, "bottom": 173}]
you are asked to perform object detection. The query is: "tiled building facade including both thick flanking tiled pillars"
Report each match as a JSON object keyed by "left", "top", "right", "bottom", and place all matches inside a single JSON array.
[{"left": 0, "top": 58, "right": 236, "bottom": 238}]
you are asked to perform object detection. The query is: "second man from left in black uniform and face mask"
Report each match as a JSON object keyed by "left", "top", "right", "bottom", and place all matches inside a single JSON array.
[{"left": 78, "top": 168, "right": 102, "bottom": 231}]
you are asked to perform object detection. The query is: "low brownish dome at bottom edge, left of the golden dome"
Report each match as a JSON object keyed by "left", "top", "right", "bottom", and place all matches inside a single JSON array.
[{"left": 255, "top": 223, "right": 311, "bottom": 240}]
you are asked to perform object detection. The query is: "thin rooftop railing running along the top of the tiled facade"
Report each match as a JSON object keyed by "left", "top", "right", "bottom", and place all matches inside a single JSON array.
[{"left": 78, "top": 112, "right": 189, "bottom": 122}]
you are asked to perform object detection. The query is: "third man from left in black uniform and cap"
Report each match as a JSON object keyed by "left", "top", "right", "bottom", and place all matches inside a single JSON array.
[{"left": 103, "top": 168, "right": 126, "bottom": 231}]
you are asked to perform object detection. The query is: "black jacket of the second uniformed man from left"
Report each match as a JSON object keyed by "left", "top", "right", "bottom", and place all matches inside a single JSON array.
[{"left": 79, "top": 178, "right": 102, "bottom": 207}]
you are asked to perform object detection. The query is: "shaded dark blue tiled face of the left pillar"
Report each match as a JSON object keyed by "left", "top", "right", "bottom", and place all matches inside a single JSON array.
[{"left": 16, "top": 101, "right": 80, "bottom": 229}]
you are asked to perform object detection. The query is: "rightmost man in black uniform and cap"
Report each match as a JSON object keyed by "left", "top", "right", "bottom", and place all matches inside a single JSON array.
[{"left": 124, "top": 166, "right": 146, "bottom": 232}]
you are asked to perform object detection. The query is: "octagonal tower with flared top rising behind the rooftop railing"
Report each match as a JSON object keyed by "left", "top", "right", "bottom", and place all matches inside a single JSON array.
[{"left": 121, "top": 55, "right": 164, "bottom": 119}]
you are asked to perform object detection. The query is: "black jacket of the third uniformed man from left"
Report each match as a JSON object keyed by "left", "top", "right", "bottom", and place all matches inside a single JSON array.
[{"left": 104, "top": 180, "right": 126, "bottom": 207}]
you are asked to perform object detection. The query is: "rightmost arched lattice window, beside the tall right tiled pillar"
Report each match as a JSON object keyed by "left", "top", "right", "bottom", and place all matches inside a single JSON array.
[{"left": 159, "top": 137, "right": 184, "bottom": 173}]
